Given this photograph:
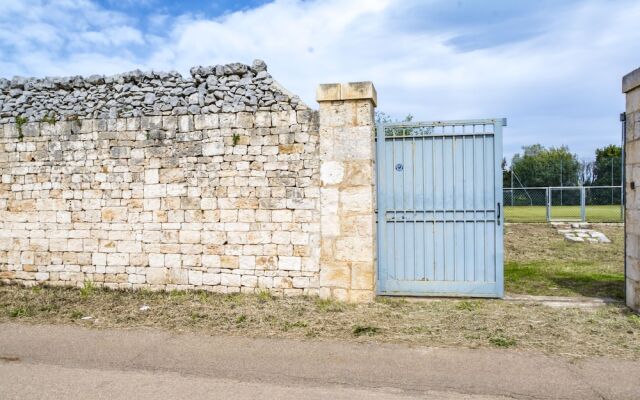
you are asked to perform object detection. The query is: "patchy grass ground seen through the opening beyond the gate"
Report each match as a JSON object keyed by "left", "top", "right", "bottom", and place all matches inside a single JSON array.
[{"left": 504, "top": 224, "right": 624, "bottom": 299}]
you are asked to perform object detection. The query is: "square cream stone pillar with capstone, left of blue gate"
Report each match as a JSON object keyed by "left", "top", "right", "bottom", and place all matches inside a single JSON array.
[{"left": 317, "top": 82, "right": 377, "bottom": 302}]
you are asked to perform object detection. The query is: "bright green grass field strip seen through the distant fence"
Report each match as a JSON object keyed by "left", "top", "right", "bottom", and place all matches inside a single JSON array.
[{"left": 504, "top": 205, "right": 622, "bottom": 222}]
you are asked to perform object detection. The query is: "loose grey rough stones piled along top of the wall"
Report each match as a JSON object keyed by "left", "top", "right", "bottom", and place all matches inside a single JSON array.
[{"left": 0, "top": 60, "right": 308, "bottom": 123}]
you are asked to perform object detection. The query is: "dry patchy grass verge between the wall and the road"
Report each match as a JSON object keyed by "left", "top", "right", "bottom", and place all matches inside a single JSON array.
[{"left": 0, "top": 286, "right": 640, "bottom": 359}]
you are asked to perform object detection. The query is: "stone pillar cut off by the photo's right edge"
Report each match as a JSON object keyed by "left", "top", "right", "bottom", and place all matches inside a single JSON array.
[{"left": 622, "top": 68, "right": 640, "bottom": 311}]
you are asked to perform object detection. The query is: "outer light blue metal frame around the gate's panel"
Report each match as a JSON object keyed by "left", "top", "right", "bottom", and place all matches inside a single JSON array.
[{"left": 375, "top": 118, "right": 507, "bottom": 298}]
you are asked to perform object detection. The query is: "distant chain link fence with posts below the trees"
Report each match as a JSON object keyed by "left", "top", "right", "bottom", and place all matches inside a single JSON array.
[{"left": 503, "top": 186, "right": 624, "bottom": 222}]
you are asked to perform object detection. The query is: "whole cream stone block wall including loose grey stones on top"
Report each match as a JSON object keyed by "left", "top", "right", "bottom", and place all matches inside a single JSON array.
[{"left": 0, "top": 61, "right": 320, "bottom": 295}]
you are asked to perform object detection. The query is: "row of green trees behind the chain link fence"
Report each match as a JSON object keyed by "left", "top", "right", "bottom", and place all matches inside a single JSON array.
[{"left": 502, "top": 144, "right": 622, "bottom": 188}]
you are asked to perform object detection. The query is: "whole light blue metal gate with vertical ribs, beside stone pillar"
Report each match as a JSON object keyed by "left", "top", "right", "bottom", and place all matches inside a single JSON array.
[{"left": 376, "top": 119, "right": 506, "bottom": 297}]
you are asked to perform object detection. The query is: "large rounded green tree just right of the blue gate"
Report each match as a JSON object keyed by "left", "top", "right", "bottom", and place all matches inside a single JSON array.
[{"left": 511, "top": 144, "right": 580, "bottom": 187}]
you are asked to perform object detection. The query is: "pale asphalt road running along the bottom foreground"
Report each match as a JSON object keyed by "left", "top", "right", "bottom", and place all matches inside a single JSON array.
[{"left": 0, "top": 324, "right": 640, "bottom": 400}]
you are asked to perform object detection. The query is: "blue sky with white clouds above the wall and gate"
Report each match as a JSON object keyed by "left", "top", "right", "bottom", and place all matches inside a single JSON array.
[{"left": 0, "top": 0, "right": 640, "bottom": 158}]
